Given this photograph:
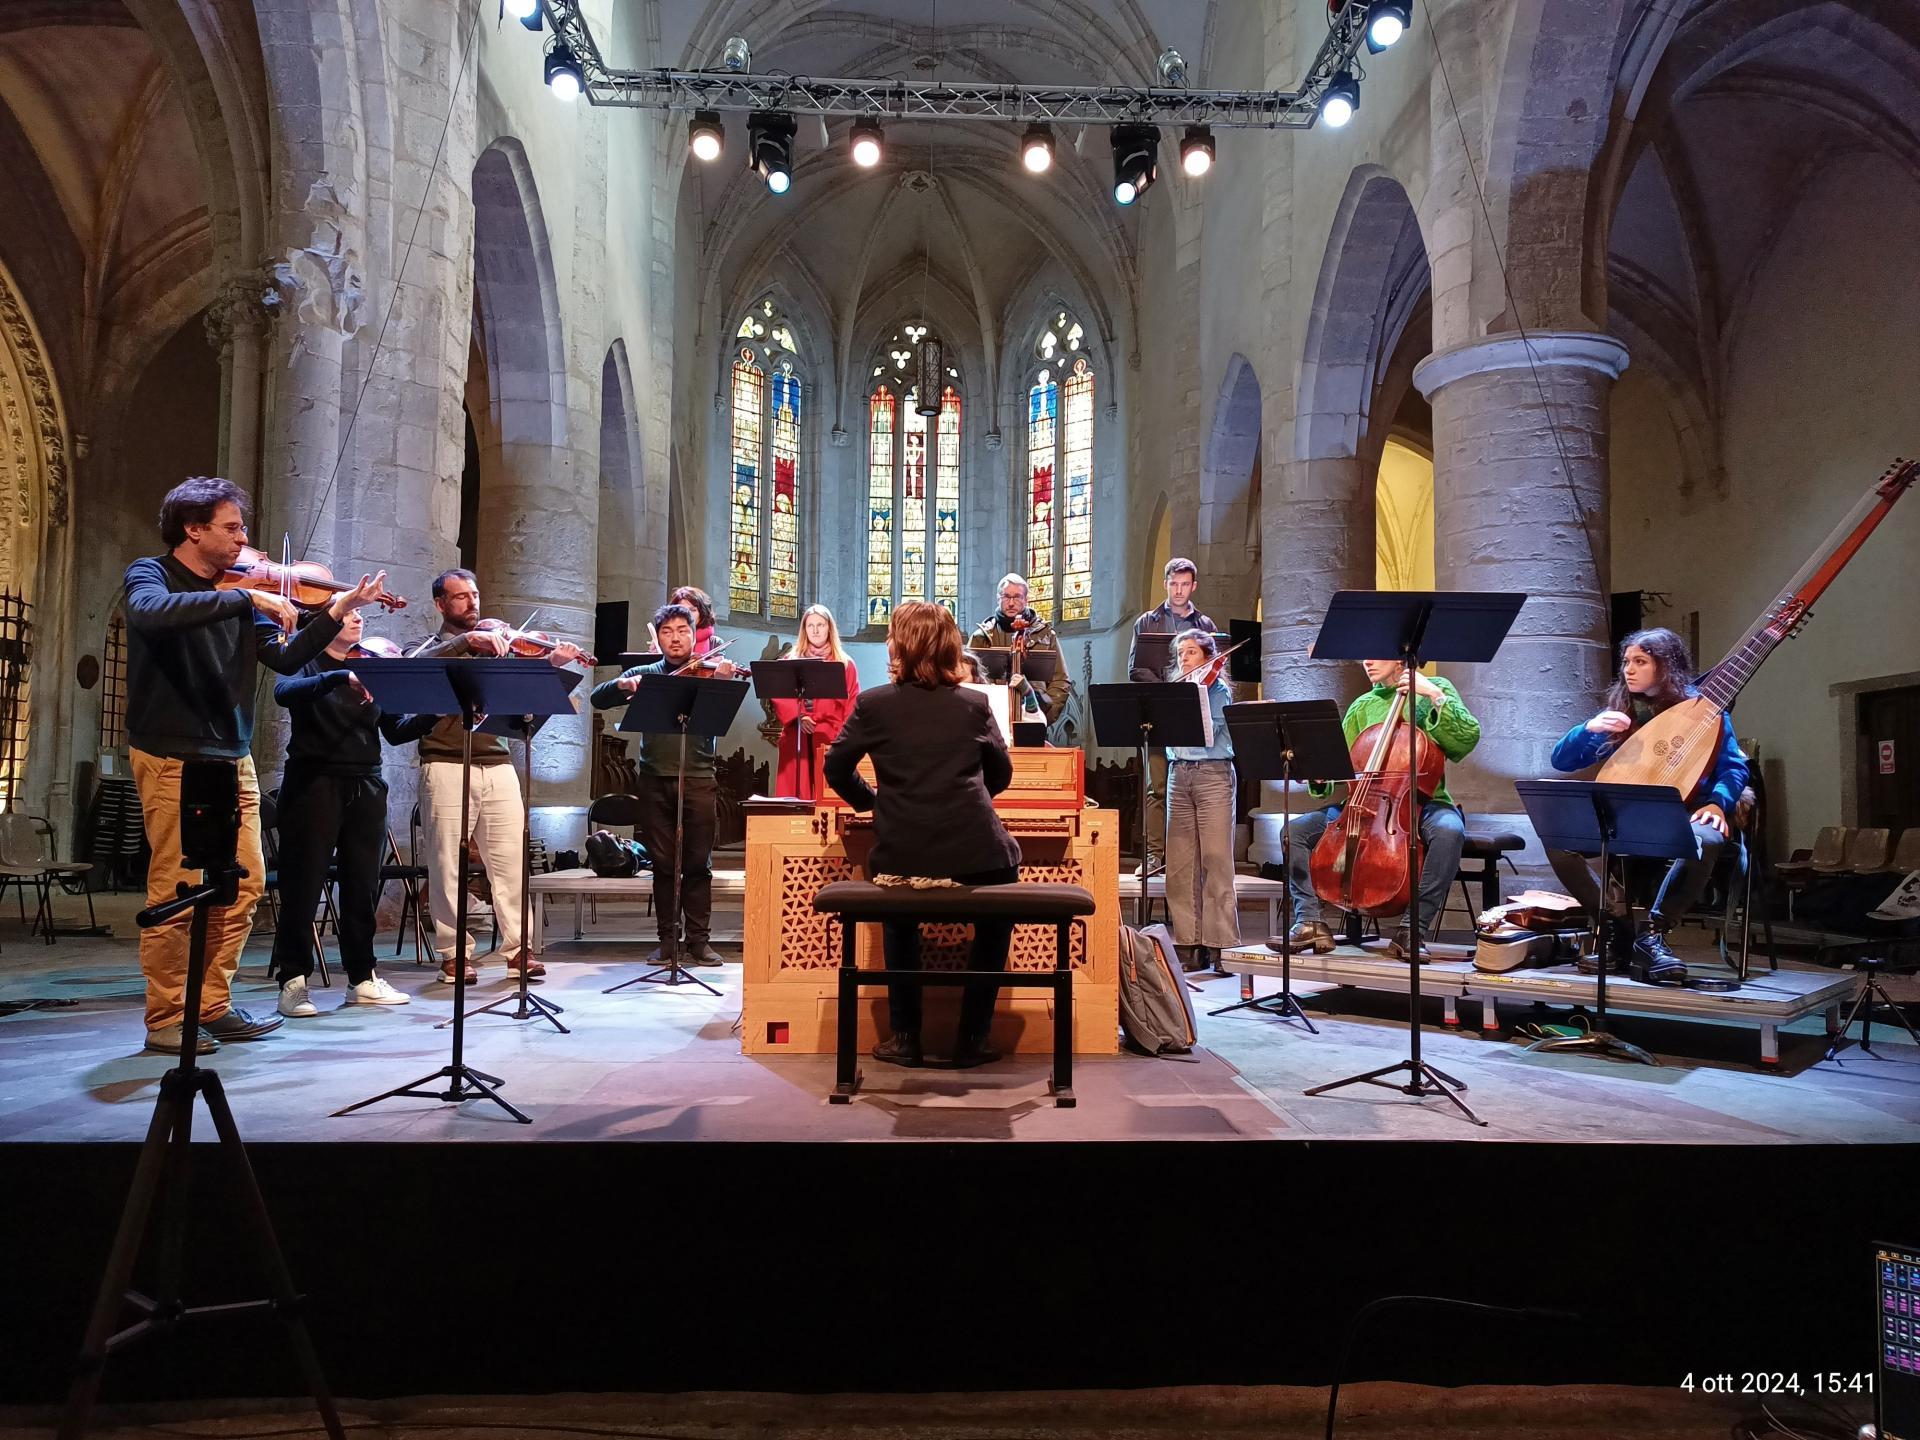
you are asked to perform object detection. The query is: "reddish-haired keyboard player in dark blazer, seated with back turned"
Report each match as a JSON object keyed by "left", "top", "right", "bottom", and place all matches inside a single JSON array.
[{"left": 826, "top": 601, "right": 1020, "bottom": 1066}]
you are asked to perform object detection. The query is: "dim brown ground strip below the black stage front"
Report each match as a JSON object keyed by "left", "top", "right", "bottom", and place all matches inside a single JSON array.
[{"left": 0, "top": 1382, "right": 1843, "bottom": 1440}]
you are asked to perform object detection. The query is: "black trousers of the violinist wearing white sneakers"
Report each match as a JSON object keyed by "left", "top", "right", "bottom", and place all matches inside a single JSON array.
[{"left": 273, "top": 768, "right": 386, "bottom": 985}]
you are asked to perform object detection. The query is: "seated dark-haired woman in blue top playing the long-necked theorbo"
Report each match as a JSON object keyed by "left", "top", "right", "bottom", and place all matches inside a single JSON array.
[{"left": 1548, "top": 628, "right": 1747, "bottom": 985}]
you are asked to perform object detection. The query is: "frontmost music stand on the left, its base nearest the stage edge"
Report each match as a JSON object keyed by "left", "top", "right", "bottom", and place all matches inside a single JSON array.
[{"left": 334, "top": 657, "right": 572, "bottom": 1125}]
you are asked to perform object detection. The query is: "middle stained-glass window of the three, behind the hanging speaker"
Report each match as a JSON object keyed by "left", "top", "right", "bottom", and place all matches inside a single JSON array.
[{"left": 866, "top": 324, "right": 968, "bottom": 626}]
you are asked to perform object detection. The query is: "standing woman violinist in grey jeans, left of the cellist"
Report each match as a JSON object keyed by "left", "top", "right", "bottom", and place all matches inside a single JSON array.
[{"left": 1165, "top": 630, "right": 1240, "bottom": 973}]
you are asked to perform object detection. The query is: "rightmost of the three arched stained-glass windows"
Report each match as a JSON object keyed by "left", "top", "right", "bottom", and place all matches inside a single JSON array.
[{"left": 1016, "top": 305, "right": 1102, "bottom": 624}]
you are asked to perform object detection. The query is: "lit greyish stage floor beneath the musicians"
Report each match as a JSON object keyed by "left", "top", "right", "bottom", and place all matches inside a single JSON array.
[{"left": 0, "top": 897, "right": 1920, "bottom": 1144}]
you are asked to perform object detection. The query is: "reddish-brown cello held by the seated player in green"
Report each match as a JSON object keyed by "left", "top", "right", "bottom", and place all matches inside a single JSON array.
[{"left": 1311, "top": 689, "right": 1446, "bottom": 916}]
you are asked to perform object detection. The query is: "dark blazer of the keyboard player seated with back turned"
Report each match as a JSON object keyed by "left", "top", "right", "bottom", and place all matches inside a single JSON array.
[{"left": 826, "top": 684, "right": 1020, "bottom": 879}]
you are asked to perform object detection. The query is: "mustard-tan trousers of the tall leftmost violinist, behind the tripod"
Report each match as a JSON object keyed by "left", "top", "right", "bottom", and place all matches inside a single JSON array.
[{"left": 129, "top": 751, "right": 267, "bottom": 1031}]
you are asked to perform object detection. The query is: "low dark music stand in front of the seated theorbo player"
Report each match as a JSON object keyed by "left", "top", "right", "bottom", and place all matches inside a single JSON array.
[{"left": 1513, "top": 780, "right": 1699, "bottom": 1066}]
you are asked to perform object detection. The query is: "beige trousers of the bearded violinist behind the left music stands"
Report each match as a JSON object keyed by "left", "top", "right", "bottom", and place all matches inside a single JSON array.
[{"left": 420, "top": 760, "right": 526, "bottom": 964}]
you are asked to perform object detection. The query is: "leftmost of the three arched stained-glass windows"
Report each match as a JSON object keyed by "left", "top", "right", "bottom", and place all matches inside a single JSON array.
[{"left": 722, "top": 296, "right": 812, "bottom": 620}]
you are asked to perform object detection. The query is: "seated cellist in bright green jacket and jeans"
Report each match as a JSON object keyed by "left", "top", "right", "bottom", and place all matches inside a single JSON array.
[{"left": 1286, "top": 660, "right": 1480, "bottom": 958}]
